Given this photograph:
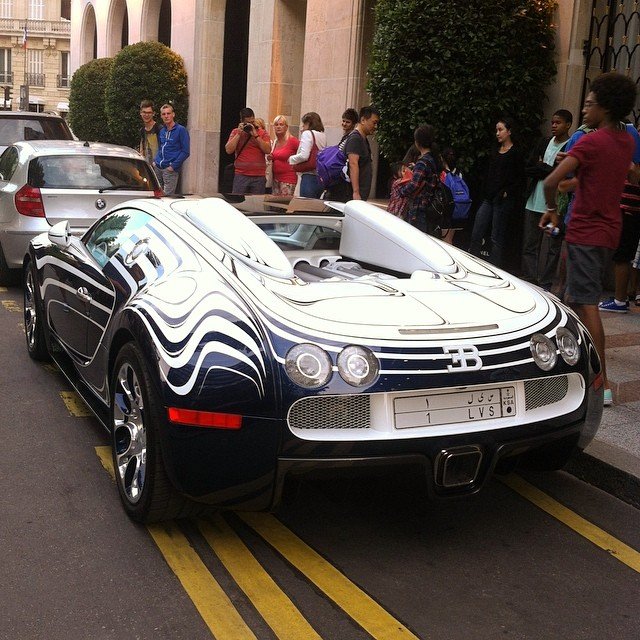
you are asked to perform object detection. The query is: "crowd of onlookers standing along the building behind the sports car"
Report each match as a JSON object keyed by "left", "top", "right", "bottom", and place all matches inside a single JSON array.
[{"left": 140, "top": 72, "right": 640, "bottom": 404}]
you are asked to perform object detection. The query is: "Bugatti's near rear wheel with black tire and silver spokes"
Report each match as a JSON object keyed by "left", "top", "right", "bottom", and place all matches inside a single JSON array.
[{"left": 109, "top": 342, "right": 191, "bottom": 523}]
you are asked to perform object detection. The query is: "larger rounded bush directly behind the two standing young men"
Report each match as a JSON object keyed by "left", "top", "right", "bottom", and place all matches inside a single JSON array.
[{"left": 105, "top": 42, "right": 189, "bottom": 147}]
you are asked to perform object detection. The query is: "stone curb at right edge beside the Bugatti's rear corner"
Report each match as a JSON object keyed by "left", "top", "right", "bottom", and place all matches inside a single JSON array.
[{"left": 564, "top": 440, "right": 640, "bottom": 509}]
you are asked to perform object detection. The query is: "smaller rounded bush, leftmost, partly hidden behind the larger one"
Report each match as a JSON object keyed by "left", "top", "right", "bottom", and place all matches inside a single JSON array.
[{"left": 68, "top": 58, "right": 113, "bottom": 142}]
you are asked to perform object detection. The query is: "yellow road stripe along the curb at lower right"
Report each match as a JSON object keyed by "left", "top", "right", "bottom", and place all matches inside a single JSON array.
[{"left": 502, "top": 474, "right": 640, "bottom": 573}]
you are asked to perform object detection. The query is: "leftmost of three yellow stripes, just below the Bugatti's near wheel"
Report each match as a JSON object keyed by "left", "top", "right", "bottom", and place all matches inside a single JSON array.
[{"left": 147, "top": 522, "right": 256, "bottom": 640}]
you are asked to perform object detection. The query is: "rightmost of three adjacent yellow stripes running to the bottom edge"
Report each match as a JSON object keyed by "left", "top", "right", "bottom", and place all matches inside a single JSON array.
[{"left": 239, "top": 513, "right": 417, "bottom": 640}]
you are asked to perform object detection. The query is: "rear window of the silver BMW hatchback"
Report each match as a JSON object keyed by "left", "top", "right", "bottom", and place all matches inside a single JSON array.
[{"left": 29, "top": 155, "right": 157, "bottom": 191}]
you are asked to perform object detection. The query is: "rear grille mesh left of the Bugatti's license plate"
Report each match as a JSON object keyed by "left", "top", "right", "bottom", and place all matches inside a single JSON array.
[{"left": 289, "top": 394, "right": 371, "bottom": 429}]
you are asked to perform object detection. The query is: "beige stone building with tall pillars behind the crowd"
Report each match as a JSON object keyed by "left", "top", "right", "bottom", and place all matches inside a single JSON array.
[{"left": 69, "top": 0, "right": 640, "bottom": 194}]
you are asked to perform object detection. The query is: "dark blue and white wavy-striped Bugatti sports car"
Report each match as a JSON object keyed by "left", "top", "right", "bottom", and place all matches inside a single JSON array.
[{"left": 24, "top": 198, "right": 603, "bottom": 521}]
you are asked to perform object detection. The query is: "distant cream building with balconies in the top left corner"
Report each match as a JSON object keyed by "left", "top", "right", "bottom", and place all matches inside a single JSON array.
[{"left": 0, "top": 0, "right": 71, "bottom": 116}]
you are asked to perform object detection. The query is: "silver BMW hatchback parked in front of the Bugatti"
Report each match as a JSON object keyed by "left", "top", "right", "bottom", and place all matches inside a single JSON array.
[{"left": 0, "top": 140, "right": 162, "bottom": 284}]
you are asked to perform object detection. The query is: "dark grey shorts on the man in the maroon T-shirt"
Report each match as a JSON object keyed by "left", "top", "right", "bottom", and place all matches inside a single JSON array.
[{"left": 565, "top": 243, "right": 613, "bottom": 305}]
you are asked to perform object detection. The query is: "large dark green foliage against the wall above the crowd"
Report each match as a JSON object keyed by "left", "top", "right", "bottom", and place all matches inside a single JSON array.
[{"left": 368, "top": 0, "right": 561, "bottom": 171}]
